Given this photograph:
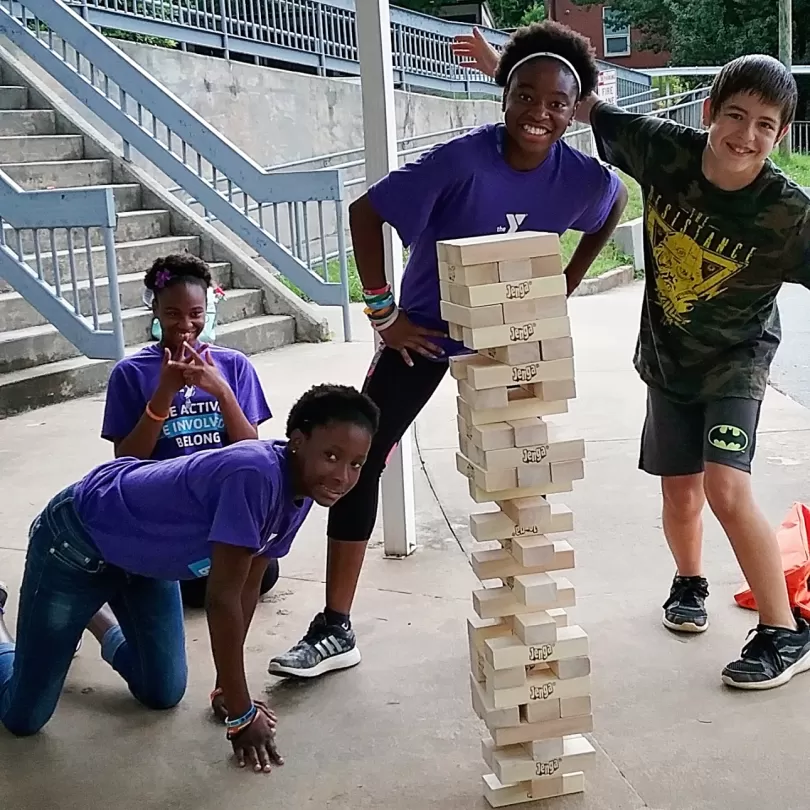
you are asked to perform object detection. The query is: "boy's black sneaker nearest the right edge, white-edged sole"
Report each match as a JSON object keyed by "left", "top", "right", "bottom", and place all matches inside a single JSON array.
[{"left": 723, "top": 615, "right": 810, "bottom": 689}]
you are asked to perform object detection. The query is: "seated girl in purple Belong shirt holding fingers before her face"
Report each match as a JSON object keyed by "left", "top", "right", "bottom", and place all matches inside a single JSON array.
[{"left": 101, "top": 253, "right": 278, "bottom": 608}]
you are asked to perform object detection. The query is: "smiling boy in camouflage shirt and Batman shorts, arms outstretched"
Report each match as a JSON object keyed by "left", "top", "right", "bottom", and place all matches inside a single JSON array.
[{"left": 453, "top": 32, "right": 810, "bottom": 689}]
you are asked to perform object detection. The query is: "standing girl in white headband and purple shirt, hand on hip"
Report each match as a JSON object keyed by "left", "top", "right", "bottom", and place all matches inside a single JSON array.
[{"left": 269, "top": 22, "right": 627, "bottom": 678}]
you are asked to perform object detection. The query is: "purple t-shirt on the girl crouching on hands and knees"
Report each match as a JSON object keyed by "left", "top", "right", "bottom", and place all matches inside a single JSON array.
[{"left": 74, "top": 440, "right": 312, "bottom": 580}]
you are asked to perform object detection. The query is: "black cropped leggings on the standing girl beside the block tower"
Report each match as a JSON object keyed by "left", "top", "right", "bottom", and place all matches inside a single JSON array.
[{"left": 328, "top": 348, "right": 448, "bottom": 542}]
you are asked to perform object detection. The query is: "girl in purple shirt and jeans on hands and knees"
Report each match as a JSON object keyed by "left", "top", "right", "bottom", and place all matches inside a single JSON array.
[{"left": 0, "top": 384, "right": 378, "bottom": 772}]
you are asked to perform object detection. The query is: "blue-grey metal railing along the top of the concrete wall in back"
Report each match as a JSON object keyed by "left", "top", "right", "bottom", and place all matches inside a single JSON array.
[{"left": 69, "top": 0, "right": 651, "bottom": 97}]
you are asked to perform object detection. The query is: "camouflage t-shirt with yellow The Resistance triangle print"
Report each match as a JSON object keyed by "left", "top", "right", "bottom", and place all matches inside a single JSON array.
[{"left": 591, "top": 103, "right": 810, "bottom": 403}]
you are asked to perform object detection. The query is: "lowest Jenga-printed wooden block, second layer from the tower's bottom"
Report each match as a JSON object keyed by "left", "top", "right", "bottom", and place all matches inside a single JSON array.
[{"left": 484, "top": 734, "right": 596, "bottom": 783}]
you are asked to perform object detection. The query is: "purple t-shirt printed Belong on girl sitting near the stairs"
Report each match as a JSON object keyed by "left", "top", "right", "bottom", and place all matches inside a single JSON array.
[{"left": 101, "top": 344, "right": 271, "bottom": 459}]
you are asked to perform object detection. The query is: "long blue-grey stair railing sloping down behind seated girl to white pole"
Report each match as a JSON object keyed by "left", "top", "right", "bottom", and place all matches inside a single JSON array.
[{"left": 0, "top": 0, "right": 351, "bottom": 340}]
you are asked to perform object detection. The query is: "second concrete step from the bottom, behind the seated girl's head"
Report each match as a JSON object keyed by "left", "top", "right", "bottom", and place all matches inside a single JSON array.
[{"left": 0, "top": 289, "right": 263, "bottom": 374}]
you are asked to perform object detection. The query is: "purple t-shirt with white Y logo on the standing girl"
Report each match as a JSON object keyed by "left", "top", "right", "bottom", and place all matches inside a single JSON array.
[{"left": 368, "top": 124, "right": 619, "bottom": 355}]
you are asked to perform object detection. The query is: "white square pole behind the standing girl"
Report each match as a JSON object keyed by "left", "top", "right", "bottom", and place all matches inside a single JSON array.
[{"left": 355, "top": 0, "right": 416, "bottom": 557}]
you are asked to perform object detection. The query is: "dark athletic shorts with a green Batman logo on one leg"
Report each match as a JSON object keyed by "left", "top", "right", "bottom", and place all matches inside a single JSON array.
[{"left": 638, "top": 388, "right": 762, "bottom": 476}]
